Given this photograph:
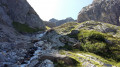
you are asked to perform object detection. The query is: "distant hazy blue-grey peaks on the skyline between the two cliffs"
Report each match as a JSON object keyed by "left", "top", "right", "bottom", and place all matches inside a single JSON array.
[{"left": 49, "top": 17, "right": 76, "bottom": 26}]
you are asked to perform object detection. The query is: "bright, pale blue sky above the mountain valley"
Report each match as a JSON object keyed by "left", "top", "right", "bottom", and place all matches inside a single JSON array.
[{"left": 27, "top": 0, "right": 93, "bottom": 21}]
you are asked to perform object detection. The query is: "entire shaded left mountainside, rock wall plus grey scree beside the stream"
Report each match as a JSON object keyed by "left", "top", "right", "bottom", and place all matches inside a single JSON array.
[{"left": 0, "top": 0, "right": 45, "bottom": 67}]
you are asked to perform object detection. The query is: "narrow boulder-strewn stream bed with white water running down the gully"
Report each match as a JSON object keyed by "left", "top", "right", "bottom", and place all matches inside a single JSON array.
[{"left": 20, "top": 32, "right": 54, "bottom": 67}]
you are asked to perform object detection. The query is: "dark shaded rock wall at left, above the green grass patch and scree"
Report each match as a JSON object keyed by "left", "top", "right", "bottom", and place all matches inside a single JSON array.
[{"left": 0, "top": 0, "right": 45, "bottom": 29}]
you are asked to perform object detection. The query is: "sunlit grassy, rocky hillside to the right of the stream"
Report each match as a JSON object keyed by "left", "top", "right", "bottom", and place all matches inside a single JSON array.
[{"left": 46, "top": 21, "right": 120, "bottom": 67}]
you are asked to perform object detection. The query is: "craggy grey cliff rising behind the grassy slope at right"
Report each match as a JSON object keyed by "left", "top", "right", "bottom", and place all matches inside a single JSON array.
[{"left": 78, "top": 0, "right": 120, "bottom": 25}]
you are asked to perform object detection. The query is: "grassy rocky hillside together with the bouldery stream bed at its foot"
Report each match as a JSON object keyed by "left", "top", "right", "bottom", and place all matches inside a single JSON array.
[{"left": 16, "top": 21, "right": 120, "bottom": 67}]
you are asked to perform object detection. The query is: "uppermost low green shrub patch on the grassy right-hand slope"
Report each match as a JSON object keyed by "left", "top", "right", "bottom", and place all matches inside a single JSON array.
[{"left": 78, "top": 30, "right": 105, "bottom": 42}]
